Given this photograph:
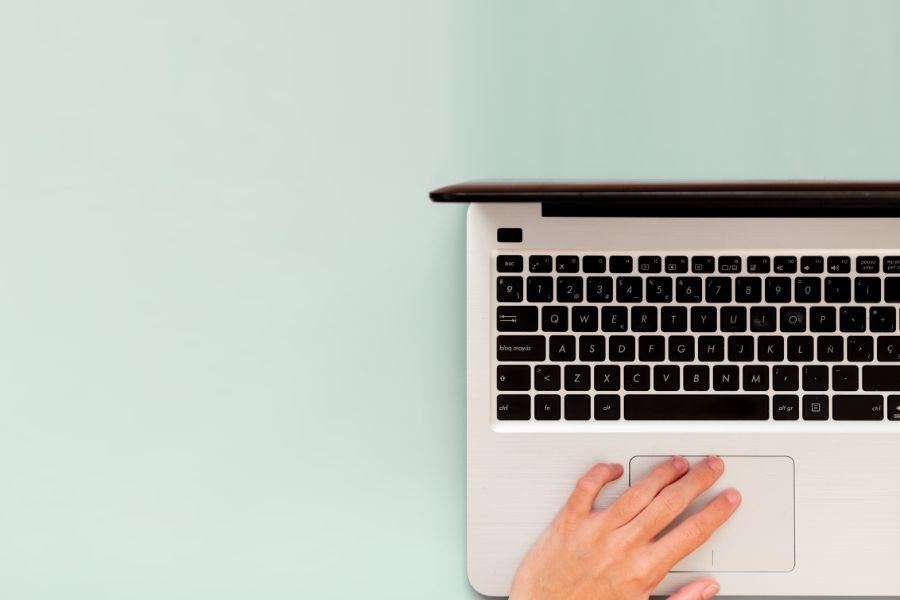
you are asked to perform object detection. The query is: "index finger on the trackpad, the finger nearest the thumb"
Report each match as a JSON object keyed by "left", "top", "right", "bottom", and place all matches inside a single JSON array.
[{"left": 651, "top": 489, "right": 741, "bottom": 571}]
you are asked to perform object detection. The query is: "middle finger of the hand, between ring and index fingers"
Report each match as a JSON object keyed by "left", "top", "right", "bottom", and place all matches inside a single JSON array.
[{"left": 628, "top": 456, "right": 725, "bottom": 540}]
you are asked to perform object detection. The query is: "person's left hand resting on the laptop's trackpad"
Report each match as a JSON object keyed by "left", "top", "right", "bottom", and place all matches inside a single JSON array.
[{"left": 509, "top": 456, "right": 741, "bottom": 600}]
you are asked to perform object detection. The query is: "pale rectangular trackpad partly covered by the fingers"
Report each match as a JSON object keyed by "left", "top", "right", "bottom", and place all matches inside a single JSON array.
[{"left": 628, "top": 456, "right": 794, "bottom": 573}]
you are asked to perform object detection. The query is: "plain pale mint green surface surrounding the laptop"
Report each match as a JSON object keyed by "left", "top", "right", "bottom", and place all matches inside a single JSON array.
[{"left": 0, "top": 0, "right": 900, "bottom": 599}]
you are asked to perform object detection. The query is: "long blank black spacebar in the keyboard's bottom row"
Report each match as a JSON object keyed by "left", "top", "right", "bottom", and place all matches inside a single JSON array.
[{"left": 625, "top": 394, "right": 769, "bottom": 421}]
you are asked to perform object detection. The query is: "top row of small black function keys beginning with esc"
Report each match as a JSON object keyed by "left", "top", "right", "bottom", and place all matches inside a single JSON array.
[{"left": 497, "top": 254, "right": 900, "bottom": 274}]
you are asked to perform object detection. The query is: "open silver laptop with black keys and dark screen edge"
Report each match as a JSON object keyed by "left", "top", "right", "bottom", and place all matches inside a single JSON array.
[{"left": 431, "top": 181, "right": 900, "bottom": 596}]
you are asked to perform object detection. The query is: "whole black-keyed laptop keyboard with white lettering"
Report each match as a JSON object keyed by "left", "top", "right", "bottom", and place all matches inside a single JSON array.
[{"left": 494, "top": 253, "right": 900, "bottom": 421}]
